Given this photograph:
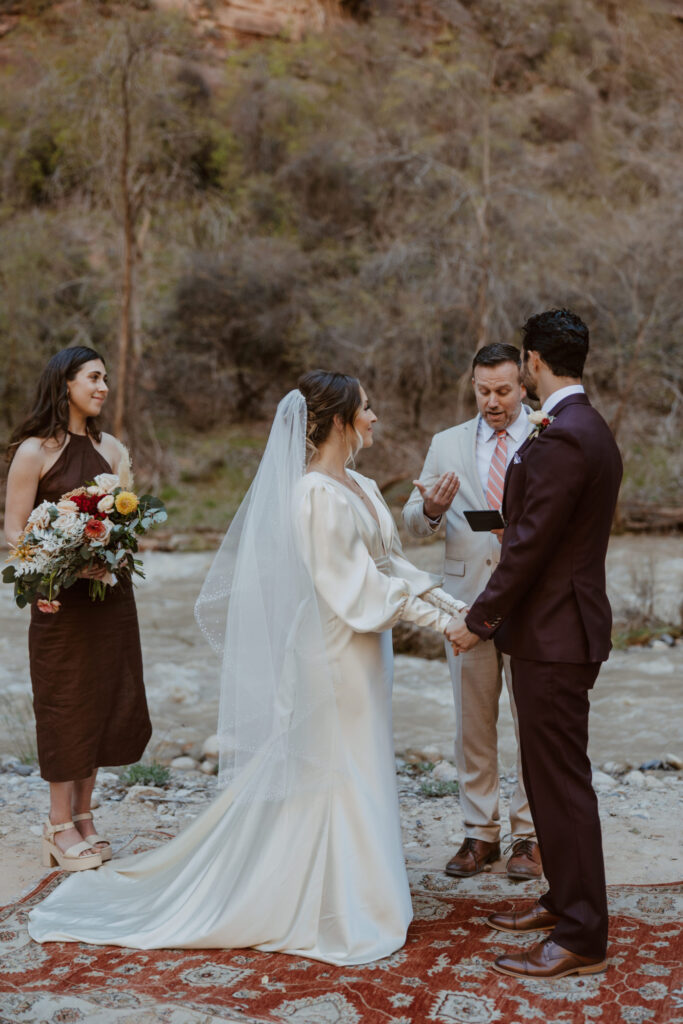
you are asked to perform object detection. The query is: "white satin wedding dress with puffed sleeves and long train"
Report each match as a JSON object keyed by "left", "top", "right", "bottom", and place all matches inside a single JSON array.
[{"left": 29, "top": 472, "right": 458, "bottom": 965}]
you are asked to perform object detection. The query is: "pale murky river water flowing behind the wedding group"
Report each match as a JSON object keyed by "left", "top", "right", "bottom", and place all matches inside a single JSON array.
[{"left": 0, "top": 537, "right": 683, "bottom": 768}]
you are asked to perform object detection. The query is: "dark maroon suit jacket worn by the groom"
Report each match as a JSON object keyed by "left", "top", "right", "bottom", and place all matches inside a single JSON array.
[{"left": 466, "top": 394, "right": 622, "bottom": 663}]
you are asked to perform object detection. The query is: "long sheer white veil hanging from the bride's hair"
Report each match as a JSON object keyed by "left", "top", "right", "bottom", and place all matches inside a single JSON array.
[{"left": 195, "top": 390, "right": 339, "bottom": 800}]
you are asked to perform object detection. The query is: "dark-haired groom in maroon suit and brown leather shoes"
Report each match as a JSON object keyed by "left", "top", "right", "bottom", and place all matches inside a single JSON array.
[{"left": 449, "top": 309, "right": 622, "bottom": 978}]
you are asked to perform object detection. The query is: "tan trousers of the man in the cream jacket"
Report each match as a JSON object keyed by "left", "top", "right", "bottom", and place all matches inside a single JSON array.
[{"left": 445, "top": 640, "right": 535, "bottom": 843}]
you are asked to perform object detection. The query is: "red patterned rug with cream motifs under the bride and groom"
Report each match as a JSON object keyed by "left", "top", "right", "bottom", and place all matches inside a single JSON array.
[{"left": 0, "top": 834, "right": 683, "bottom": 1024}]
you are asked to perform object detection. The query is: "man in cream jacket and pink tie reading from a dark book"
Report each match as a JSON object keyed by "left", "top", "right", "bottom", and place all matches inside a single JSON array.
[{"left": 403, "top": 344, "right": 542, "bottom": 879}]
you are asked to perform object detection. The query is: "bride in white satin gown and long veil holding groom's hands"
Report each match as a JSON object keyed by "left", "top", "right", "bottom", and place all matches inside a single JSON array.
[{"left": 29, "top": 371, "right": 464, "bottom": 965}]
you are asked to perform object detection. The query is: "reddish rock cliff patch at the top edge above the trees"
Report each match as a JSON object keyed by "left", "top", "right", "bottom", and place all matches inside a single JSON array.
[{"left": 158, "top": 0, "right": 341, "bottom": 41}]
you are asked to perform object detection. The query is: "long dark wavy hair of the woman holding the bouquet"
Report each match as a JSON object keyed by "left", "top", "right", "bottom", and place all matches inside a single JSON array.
[{"left": 7, "top": 345, "right": 104, "bottom": 462}]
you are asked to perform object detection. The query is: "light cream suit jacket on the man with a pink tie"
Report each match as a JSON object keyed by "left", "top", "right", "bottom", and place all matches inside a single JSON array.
[{"left": 402, "top": 416, "right": 501, "bottom": 605}]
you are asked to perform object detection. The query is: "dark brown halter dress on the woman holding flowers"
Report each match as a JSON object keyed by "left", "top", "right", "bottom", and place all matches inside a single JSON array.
[{"left": 29, "top": 434, "right": 152, "bottom": 782}]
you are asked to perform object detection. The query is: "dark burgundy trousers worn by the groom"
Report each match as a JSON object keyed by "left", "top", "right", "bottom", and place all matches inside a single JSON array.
[{"left": 511, "top": 657, "right": 607, "bottom": 957}]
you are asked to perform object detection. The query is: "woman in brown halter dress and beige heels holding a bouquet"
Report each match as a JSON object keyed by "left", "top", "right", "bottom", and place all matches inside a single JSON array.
[{"left": 5, "top": 346, "right": 152, "bottom": 871}]
